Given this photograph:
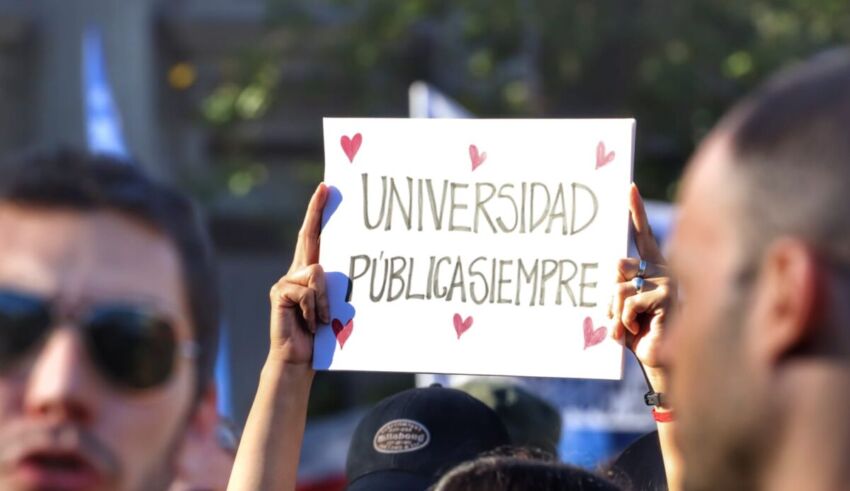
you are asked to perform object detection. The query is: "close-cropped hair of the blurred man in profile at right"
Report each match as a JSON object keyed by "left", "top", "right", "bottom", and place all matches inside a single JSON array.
[{"left": 722, "top": 48, "right": 850, "bottom": 262}]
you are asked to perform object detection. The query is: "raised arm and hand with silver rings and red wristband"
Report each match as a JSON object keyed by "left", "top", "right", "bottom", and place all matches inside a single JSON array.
[{"left": 610, "top": 185, "right": 682, "bottom": 491}]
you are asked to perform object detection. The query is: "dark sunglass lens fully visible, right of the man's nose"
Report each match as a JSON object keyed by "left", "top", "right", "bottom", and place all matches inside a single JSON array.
[{"left": 85, "top": 307, "right": 176, "bottom": 389}]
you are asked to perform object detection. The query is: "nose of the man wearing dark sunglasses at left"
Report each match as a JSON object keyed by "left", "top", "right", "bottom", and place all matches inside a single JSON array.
[{"left": 24, "top": 327, "right": 98, "bottom": 424}]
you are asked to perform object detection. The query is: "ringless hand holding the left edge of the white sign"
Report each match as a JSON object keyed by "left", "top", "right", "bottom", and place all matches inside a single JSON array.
[{"left": 269, "top": 184, "right": 330, "bottom": 366}]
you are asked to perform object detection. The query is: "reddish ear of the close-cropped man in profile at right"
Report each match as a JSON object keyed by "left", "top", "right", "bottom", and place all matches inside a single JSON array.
[{"left": 749, "top": 238, "right": 822, "bottom": 363}]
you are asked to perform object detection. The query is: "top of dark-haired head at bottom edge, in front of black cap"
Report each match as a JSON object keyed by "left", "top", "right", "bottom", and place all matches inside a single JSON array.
[{"left": 431, "top": 457, "right": 619, "bottom": 491}]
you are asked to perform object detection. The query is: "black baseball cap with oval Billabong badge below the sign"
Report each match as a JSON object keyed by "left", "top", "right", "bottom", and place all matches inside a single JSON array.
[{"left": 345, "top": 386, "right": 510, "bottom": 491}]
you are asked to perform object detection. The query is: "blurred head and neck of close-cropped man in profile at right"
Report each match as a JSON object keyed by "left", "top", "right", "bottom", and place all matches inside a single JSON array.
[{"left": 661, "top": 50, "right": 850, "bottom": 490}]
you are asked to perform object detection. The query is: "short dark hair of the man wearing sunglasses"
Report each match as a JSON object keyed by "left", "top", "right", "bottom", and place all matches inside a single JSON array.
[{"left": 0, "top": 149, "right": 219, "bottom": 395}]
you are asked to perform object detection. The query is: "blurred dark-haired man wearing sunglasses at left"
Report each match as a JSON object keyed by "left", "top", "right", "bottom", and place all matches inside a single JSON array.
[{"left": 0, "top": 152, "right": 218, "bottom": 490}]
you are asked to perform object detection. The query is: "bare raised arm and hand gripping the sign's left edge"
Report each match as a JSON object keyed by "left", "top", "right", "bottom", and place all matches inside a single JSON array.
[{"left": 227, "top": 184, "right": 329, "bottom": 491}]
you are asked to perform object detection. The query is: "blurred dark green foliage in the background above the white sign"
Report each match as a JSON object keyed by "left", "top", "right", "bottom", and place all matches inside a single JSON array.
[{"left": 204, "top": 0, "right": 850, "bottom": 199}]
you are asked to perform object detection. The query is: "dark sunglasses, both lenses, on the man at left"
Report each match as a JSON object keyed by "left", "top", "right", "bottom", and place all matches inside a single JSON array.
[{"left": 0, "top": 288, "right": 198, "bottom": 390}]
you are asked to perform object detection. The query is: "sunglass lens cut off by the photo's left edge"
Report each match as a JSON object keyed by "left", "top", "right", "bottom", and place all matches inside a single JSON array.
[{"left": 0, "top": 290, "right": 50, "bottom": 368}]
